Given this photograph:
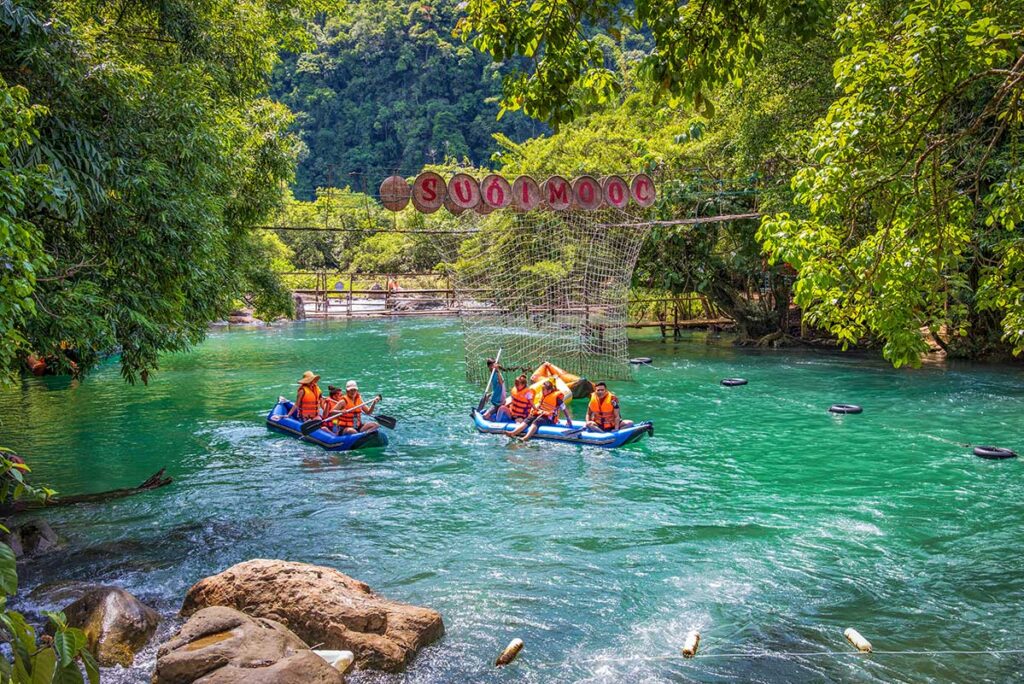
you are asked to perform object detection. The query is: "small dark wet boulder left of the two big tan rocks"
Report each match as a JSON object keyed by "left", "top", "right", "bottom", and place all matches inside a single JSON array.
[{"left": 63, "top": 587, "right": 160, "bottom": 668}]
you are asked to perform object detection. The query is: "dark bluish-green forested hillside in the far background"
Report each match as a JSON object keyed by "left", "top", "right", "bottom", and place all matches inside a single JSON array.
[{"left": 272, "top": 0, "right": 548, "bottom": 200}]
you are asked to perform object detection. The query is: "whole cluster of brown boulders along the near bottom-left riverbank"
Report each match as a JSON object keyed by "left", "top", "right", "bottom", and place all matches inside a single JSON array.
[{"left": 9, "top": 521, "right": 444, "bottom": 684}]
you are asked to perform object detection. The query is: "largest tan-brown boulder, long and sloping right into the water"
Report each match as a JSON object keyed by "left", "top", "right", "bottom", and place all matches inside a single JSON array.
[{"left": 181, "top": 559, "right": 444, "bottom": 672}]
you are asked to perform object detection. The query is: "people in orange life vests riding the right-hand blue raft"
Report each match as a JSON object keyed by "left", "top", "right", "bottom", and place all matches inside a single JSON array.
[{"left": 483, "top": 358, "right": 633, "bottom": 441}]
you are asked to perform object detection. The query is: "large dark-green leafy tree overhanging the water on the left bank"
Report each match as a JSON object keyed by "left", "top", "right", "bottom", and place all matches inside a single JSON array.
[{"left": 0, "top": 0, "right": 321, "bottom": 382}]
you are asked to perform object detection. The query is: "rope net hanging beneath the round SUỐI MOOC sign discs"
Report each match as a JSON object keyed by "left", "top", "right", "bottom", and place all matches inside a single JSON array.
[{"left": 438, "top": 202, "right": 649, "bottom": 382}]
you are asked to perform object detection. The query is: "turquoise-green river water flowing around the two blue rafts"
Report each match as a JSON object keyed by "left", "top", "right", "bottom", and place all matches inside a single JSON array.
[{"left": 0, "top": 319, "right": 1024, "bottom": 682}]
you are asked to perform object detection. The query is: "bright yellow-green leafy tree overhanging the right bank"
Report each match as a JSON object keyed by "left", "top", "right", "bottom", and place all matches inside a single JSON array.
[{"left": 760, "top": 0, "right": 1024, "bottom": 366}]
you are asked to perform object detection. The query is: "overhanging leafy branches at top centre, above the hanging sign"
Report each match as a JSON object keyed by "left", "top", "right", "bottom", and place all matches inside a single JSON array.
[{"left": 459, "top": 0, "right": 825, "bottom": 126}]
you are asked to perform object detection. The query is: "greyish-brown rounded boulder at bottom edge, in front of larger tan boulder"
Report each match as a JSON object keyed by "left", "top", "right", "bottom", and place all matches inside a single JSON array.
[{"left": 153, "top": 606, "right": 344, "bottom": 684}]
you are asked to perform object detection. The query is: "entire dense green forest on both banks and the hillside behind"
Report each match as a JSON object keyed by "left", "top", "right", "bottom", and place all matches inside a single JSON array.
[{"left": 0, "top": 0, "right": 1024, "bottom": 380}]
